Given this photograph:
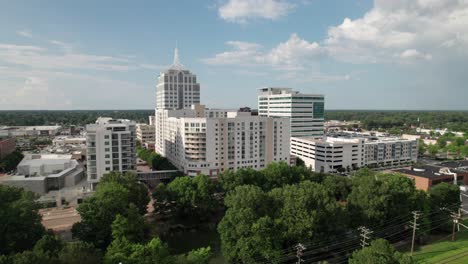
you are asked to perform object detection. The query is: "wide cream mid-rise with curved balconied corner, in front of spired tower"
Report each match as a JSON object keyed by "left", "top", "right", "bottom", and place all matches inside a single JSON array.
[{"left": 156, "top": 105, "right": 290, "bottom": 177}]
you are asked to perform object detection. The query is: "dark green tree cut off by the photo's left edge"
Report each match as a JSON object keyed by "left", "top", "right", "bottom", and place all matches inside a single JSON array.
[{"left": 0, "top": 185, "right": 45, "bottom": 255}]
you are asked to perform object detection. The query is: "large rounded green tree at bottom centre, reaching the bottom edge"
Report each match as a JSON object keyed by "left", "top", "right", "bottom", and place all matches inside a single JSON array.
[{"left": 218, "top": 185, "right": 281, "bottom": 263}]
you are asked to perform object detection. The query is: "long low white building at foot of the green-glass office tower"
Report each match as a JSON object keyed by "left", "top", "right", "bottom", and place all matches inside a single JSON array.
[{"left": 291, "top": 132, "right": 418, "bottom": 173}]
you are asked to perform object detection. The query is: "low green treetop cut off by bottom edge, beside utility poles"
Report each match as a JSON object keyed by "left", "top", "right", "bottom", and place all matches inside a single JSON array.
[{"left": 349, "top": 239, "right": 414, "bottom": 264}]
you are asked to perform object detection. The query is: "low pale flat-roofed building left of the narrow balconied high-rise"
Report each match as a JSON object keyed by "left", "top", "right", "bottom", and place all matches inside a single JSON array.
[{"left": 0, "top": 154, "right": 84, "bottom": 195}]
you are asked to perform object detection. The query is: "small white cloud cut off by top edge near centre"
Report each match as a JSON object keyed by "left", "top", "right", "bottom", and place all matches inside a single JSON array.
[{"left": 218, "top": 0, "right": 295, "bottom": 23}]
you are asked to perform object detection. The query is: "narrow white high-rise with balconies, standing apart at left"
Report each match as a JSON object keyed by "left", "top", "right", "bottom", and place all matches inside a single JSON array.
[{"left": 86, "top": 117, "right": 136, "bottom": 187}]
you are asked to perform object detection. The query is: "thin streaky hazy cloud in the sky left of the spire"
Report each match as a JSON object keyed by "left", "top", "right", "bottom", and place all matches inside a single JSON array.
[{"left": 0, "top": 35, "right": 161, "bottom": 110}]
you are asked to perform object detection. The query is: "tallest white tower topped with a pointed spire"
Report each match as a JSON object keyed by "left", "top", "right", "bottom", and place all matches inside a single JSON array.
[{"left": 156, "top": 48, "right": 200, "bottom": 109}]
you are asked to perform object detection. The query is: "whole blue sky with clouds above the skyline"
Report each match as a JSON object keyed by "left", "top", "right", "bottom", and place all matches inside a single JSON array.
[{"left": 0, "top": 0, "right": 468, "bottom": 110}]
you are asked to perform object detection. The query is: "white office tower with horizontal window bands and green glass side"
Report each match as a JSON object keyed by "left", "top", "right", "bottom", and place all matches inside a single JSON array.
[{"left": 258, "top": 87, "right": 325, "bottom": 137}]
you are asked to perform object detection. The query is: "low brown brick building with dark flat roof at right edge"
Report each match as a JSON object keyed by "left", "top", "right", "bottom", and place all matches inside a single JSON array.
[{"left": 393, "top": 164, "right": 468, "bottom": 191}]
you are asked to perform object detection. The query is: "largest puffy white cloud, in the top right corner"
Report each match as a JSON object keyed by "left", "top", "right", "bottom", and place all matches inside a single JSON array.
[{"left": 324, "top": 0, "right": 468, "bottom": 63}]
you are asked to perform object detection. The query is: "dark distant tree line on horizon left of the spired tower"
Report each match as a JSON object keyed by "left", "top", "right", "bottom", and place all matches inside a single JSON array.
[{"left": 0, "top": 110, "right": 154, "bottom": 126}]
